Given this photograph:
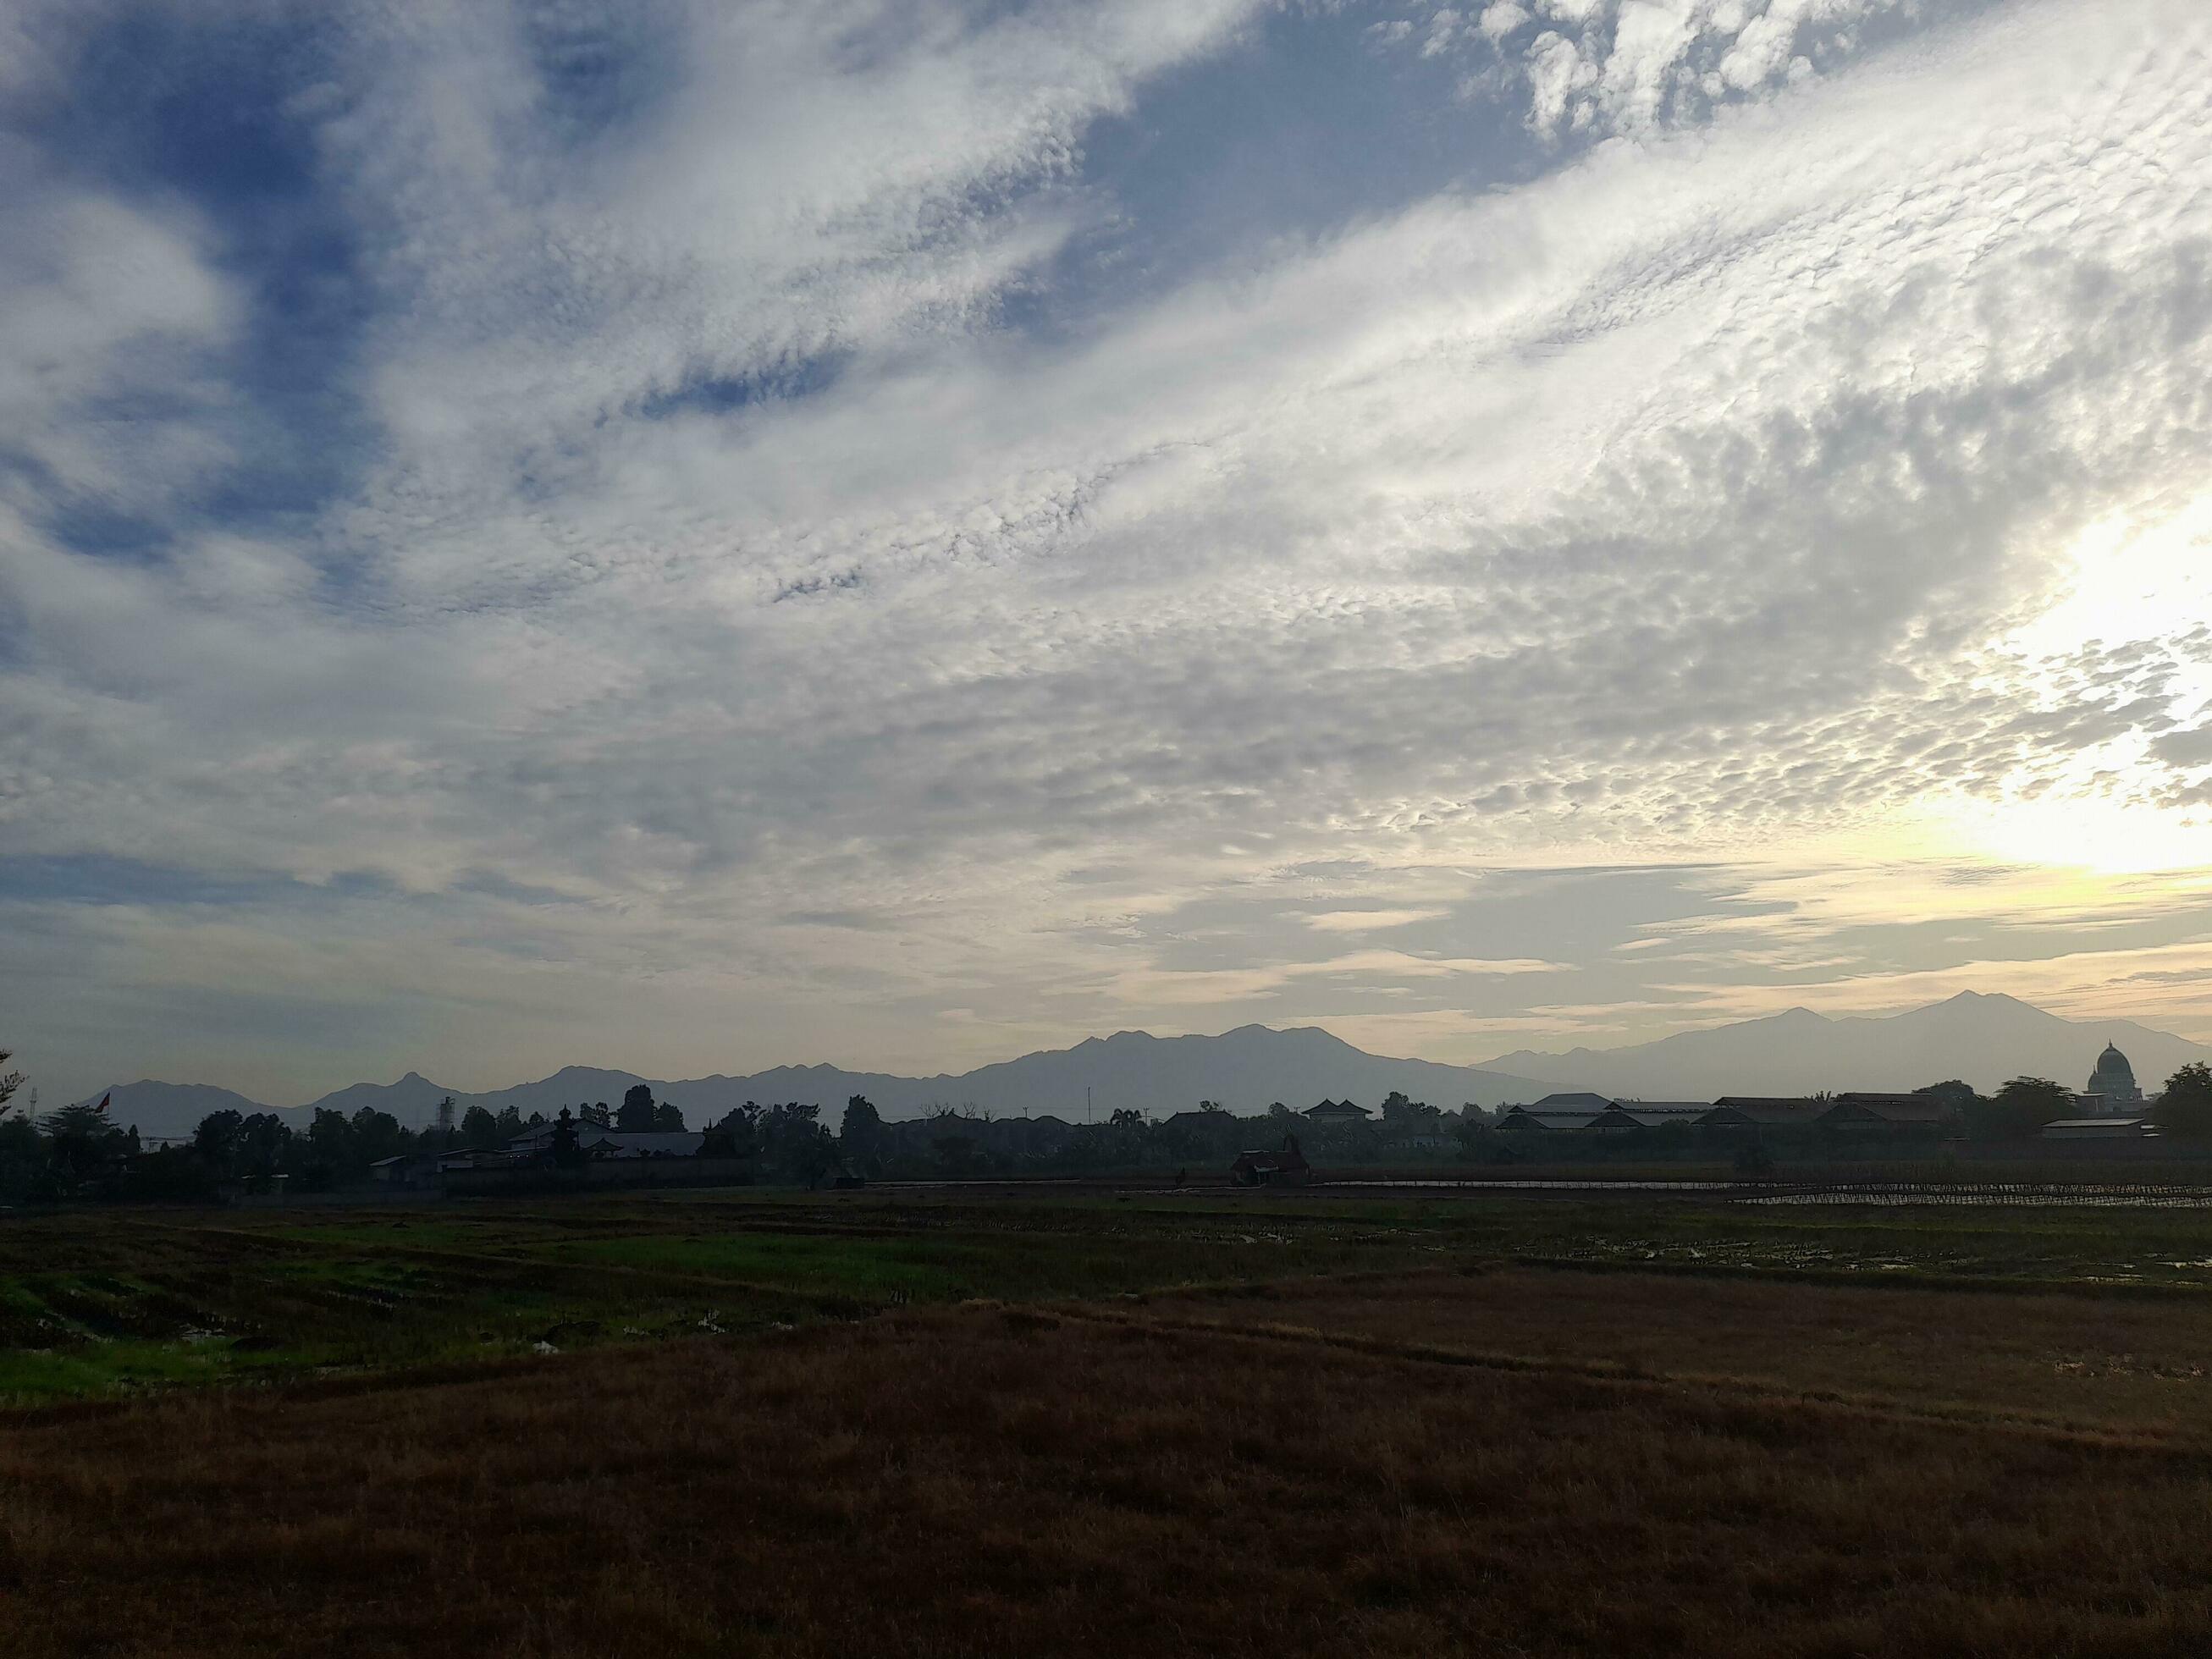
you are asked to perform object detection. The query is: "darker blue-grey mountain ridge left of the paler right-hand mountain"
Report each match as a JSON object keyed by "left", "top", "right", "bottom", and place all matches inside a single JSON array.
[{"left": 78, "top": 1027, "right": 1548, "bottom": 1135}]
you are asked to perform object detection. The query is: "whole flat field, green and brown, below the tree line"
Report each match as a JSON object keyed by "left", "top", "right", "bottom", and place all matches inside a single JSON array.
[{"left": 0, "top": 1188, "right": 2212, "bottom": 1656}]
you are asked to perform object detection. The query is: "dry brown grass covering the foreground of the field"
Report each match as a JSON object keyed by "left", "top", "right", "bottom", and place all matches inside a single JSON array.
[{"left": 0, "top": 1274, "right": 2212, "bottom": 1659}]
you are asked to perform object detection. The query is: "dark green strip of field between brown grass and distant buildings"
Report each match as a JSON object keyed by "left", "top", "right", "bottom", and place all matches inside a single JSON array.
[{"left": 0, "top": 1188, "right": 2212, "bottom": 1400}]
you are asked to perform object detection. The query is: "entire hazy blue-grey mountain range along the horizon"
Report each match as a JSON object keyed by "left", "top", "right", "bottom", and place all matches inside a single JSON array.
[{"left": 73, "top": 991, "right": 2212, "bottom": 1135}]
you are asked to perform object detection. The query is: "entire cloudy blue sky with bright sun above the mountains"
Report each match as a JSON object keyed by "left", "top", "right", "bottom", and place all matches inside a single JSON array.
[{"left": 0, "top": 0, "right": 2212, "bottom": 1119}]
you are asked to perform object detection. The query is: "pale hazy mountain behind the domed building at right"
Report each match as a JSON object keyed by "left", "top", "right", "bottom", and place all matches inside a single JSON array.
[{"left": 1489, "top": 991, "right": 2212, "bottom": 1100}]
